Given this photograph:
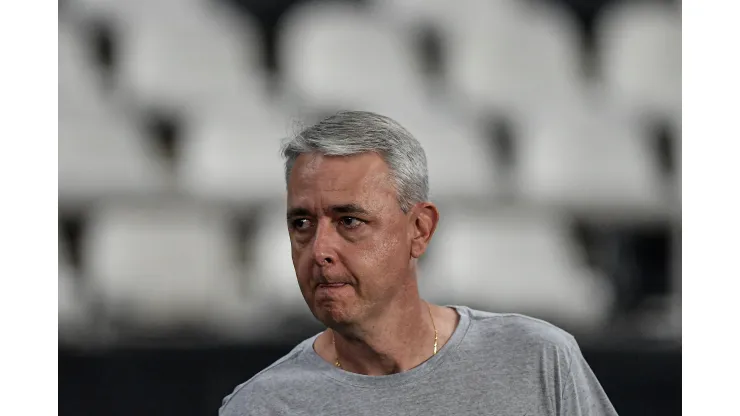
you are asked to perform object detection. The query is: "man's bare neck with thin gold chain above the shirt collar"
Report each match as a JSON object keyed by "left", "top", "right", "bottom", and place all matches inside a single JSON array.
[{"left": 331, "top": 297, "right": 435, "bottom": 375}]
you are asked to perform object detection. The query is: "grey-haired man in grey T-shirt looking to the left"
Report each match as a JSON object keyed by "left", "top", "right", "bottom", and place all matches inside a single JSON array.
[{"left": 220, "top": 112, "right": 616, "bottom": 416}]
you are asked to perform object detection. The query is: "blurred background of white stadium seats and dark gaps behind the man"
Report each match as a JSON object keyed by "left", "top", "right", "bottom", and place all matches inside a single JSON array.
[{"left": 58, "top": 0, "right": 681, "bottom": 416}]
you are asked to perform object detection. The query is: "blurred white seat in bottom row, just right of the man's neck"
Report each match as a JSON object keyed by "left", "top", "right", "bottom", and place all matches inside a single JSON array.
[{"left": 419, "top": 205, "right": 612, "bottom": 329}]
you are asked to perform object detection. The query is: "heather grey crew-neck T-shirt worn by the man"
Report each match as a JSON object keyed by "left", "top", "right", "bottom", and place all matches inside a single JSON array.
[{"left": 219, "top": 306, "right": 617, "bottom": 416}]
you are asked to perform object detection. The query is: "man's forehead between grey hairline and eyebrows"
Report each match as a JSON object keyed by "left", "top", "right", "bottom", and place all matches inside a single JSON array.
[{"left": 288, "top": 153, "right": 396, "bottom": 210}]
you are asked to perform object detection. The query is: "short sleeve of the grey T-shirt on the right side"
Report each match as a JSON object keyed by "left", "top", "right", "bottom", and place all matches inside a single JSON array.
[{"left": 560, "top": 342, "right": 617, "bottom": 416}]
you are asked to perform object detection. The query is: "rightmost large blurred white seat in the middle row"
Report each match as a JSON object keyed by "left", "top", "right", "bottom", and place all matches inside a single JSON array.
[{"left": 516, "top": 103, "right": 665, "bottom": 215}]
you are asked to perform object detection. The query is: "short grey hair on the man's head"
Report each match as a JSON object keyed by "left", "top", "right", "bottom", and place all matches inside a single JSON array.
[{"left": 282, "top": 111, "right": 429, "bottom": 212}]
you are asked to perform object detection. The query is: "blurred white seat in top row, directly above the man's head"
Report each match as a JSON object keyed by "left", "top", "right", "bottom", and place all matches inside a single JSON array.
[{"left": 278, "top": 2, "right": 423, "bottom": 110}]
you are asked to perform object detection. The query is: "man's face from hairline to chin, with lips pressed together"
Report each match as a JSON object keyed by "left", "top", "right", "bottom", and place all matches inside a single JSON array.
[{"left": 287, "top": 153, "right": 412, "bottom": 325}]
